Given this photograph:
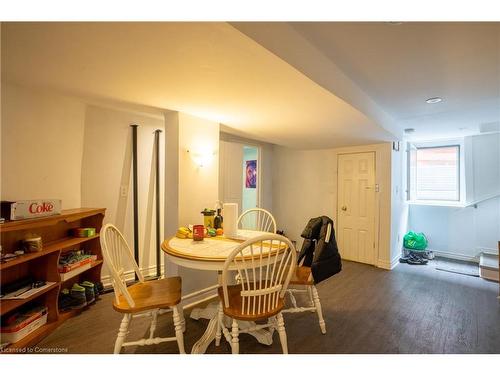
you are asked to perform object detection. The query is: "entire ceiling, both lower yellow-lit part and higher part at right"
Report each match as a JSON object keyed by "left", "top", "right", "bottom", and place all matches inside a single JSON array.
[{"left": 2, "top": 22, "right": 500, "bottom": 149}]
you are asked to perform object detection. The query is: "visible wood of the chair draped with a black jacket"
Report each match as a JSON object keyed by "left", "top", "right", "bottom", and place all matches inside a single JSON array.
[{"left": 283, "top": 224, "right": 332, "bottom": 334}]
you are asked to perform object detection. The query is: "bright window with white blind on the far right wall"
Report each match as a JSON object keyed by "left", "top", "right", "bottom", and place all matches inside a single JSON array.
[{"left": 409, "top": 145, "right": 460, "bottom": 202}]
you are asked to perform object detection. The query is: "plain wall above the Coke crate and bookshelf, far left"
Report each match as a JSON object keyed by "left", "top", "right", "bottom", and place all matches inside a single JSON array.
[{"left": 1, "top": 83, "right": 85, "bottom": 209}]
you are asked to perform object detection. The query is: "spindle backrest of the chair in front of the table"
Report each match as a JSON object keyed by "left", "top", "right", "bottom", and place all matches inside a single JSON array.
[{"left": 222, "top": 233, "right": 297, "bottom": 315}]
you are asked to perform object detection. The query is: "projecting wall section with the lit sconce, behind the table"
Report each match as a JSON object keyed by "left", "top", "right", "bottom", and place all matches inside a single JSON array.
[{"left": 165, "top": 112, "right": 219, "bottom": 294}]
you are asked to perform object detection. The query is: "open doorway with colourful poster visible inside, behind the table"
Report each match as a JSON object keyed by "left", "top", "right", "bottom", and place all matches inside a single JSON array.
[{"left": 219, "top": 141, "right": 261, "bottom": 214}]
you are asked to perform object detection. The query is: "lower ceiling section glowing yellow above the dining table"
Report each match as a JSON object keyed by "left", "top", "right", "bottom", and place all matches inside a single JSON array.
[{"left": 2, "top": 22, "right": 394, "bottom": 148}]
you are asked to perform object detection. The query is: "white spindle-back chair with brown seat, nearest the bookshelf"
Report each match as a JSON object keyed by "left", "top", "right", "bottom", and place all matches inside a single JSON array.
[{"left": 100, "top": 224, "right": 185, "bottom": 354}]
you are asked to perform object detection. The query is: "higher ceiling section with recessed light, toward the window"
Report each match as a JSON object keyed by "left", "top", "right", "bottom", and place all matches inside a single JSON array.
[{"left": 233, "top": 22, "right": 500, "bottom": 139}]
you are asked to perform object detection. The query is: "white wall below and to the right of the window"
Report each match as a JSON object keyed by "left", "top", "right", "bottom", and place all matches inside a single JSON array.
[{"left": 408, "top": 133, "right": 500, "bottom": 260}]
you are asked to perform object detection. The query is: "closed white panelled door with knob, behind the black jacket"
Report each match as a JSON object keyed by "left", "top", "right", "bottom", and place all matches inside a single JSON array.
[{"left": 337, "top": 152, "right": 376, "bottom": 265}]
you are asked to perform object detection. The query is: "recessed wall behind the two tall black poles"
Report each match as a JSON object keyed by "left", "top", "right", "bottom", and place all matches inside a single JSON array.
[{"left": 81, "top": 105, "right": 165, "bottom": 281}]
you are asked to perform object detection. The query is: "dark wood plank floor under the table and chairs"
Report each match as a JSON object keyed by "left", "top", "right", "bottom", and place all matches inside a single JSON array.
[{"left": 39, "top": 262, "right": 500, "bottom": 354}]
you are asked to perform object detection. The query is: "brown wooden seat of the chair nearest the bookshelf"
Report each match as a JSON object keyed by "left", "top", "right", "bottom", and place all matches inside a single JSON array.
[{"left": 113, "top": 277, "right": 182, "bottom": 313}]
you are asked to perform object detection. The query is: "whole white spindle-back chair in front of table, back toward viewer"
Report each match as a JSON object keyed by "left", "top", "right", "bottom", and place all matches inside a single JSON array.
[{"left": 215, "top": 234, "right": 297, "bottom": 354}]
